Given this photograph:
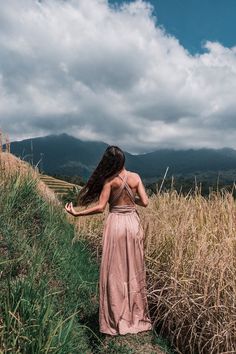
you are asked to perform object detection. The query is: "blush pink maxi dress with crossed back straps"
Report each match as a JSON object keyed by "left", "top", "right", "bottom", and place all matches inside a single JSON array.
[{"left": 99, "top": 174, "right": 152, "bottom": 335}]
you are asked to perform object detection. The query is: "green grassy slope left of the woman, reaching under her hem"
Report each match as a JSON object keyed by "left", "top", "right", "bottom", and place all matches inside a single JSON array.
[{"left": 0, "top": 158, "right": 171, "bottom": 354}]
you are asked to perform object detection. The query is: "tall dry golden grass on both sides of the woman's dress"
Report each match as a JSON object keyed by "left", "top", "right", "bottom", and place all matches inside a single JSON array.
[{"left": 76, "top": 189, "right": 236, "bottom": 354}]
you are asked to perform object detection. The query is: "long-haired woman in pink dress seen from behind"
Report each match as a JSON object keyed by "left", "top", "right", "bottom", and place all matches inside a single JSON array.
[{"left": 65, "top": 146, "right": 152, "bottom": 335}]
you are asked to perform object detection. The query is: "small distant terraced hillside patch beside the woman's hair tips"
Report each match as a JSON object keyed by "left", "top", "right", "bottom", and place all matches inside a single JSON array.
[{"left": 40, "top": 174, "right": 81, "bottom": 197}]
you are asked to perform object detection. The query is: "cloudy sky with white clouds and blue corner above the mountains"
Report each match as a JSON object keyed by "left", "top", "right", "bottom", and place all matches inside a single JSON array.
[{"left": 0, "top": 0, "right": 236, "bottom": 153}]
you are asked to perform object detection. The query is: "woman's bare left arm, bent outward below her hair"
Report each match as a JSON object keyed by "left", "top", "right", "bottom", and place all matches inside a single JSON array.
[{"left": 65, "top": 182, "right": 111, "bottom": 216}]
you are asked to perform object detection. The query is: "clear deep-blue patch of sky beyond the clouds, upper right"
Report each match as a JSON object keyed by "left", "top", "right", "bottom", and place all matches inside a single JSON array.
[{"left": 110, "top": 0, "right": 236, "bottom": 54}]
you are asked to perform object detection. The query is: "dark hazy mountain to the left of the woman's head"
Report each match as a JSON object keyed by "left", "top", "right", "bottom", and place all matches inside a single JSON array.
[{"left": 7, "top": 134, "right": 108, "bottom": 177}]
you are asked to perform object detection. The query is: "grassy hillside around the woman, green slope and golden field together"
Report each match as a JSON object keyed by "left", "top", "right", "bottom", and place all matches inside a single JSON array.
[{"left": 0, "top": 153, "right": 236, "bottom": 354}]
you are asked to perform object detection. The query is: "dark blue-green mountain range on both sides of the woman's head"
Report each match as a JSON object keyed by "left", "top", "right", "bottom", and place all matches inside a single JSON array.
[{"left": 7, "top": 134, "right": 236, "bottom": 181}]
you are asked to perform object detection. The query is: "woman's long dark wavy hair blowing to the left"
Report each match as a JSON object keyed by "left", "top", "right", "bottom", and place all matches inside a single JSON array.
[{"left": 77, "top": 145, "right": 125, "bottom": 206}]
